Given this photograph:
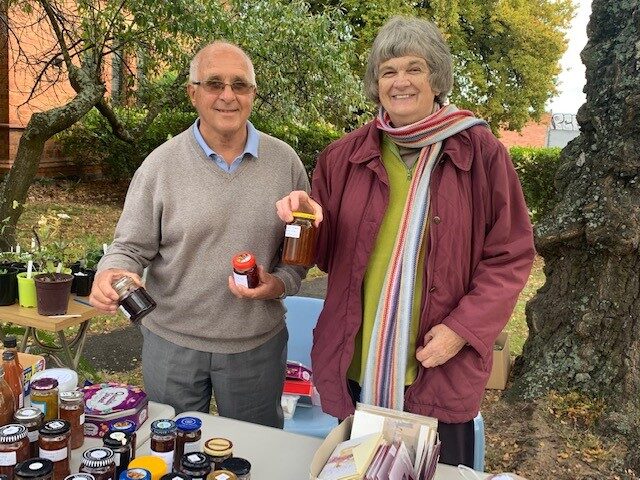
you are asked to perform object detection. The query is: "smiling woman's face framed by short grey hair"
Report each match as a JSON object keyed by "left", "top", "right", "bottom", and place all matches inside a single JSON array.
[{"left": 378, "top": 55, "right": 437, "bottom": 127}]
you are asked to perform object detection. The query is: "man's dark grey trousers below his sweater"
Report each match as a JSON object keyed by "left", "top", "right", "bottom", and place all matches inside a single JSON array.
[{"left": 140, "top": 325, "right": 289, "bottom": 428}]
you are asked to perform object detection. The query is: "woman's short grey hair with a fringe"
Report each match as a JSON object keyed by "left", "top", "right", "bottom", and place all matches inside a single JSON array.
[{"left": 364, "top": 17, "right": 453, "bottom": 105}]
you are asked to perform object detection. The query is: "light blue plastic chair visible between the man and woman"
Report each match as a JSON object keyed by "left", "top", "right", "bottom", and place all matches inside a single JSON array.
[{"left": 284, "top": 297, "right": 338, "bottom": 438}]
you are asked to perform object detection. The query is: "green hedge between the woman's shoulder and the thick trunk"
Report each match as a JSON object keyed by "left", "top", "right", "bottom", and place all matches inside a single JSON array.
[{"left": 509, "top": 147, "right": 561, "bottom": 223}]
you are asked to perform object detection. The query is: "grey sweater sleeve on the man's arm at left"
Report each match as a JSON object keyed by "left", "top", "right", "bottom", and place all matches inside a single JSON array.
[{"left": 98, "top": 165, "right": 162, "bottom": 275}]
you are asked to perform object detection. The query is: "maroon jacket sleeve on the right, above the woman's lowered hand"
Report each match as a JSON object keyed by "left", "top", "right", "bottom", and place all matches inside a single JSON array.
[{"left": 442, "top": 137, "right": 535, "bottom": 356}]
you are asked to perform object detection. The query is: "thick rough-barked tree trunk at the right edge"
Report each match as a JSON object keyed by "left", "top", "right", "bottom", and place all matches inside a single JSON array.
[{"left": 508, "top": 0, "right": 640, "bottom": 432}]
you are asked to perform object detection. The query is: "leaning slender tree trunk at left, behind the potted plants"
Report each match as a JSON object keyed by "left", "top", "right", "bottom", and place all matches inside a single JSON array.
[{"left": 0, "top": 84, "right": 105, "bottom": 250}]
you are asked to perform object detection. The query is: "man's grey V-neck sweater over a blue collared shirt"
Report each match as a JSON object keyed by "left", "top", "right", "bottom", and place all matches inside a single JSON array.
[{"left": 99, "top": 128, "right": 309, "bottom": 353}]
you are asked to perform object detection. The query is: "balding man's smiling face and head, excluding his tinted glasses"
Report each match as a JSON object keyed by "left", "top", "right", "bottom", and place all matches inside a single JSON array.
[{"left": 187, "top": 46, "right": 255, "bottom": 138}]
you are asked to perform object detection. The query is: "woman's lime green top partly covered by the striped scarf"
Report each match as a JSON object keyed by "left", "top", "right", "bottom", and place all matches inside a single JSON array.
[{"left": 347, "top": 135, "right": 426, "bottom": 385}]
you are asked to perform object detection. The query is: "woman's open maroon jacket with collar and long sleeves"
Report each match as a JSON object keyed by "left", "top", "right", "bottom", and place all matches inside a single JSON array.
[{"left": 311, "top": 122, "right": 535, "bottom": 423}]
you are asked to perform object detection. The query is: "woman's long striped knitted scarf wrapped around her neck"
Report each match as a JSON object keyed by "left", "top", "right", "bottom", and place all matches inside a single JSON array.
[{"left": 362, "top": 105, "right": 487, "bottom": 410}]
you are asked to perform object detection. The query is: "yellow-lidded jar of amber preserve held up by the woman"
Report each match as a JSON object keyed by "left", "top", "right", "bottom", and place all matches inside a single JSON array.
[{"left": 282, "top": 212, "right": 317, "bottom": 267}]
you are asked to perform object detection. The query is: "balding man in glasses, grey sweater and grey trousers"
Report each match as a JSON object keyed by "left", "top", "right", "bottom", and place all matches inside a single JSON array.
[{"left": 90, "top": 42, "right": 309, "bottom": 428}]
